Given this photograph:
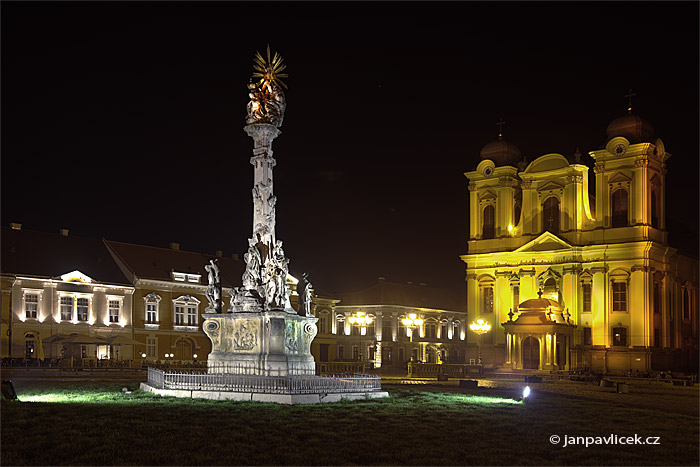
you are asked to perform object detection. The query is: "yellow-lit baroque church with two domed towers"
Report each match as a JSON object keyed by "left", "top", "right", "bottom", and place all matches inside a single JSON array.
[{"left": 461, "top": 105, "right": 698, "bottom": 372}]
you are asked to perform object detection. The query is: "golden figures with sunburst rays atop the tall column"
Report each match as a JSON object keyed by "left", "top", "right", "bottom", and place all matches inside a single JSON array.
[{"left": 246, "top": 45, "right": 288, "bottom": 128}]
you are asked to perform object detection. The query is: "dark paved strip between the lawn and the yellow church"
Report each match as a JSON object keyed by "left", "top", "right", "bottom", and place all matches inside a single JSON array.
[{"left": 382, "top": 377, "right": 700, "bottom": 417}]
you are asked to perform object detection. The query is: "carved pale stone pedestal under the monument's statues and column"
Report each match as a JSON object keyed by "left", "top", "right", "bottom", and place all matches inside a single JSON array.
[{"left": 203, "top": 310, "right": 318, "bottom": 376}]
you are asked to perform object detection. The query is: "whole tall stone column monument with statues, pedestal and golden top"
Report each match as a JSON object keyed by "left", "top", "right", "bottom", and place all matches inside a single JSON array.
[{"left": 197, "top": 46, "right": 318, "bottom": 375}]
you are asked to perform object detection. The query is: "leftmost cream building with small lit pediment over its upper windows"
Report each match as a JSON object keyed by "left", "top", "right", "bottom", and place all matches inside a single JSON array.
[{"left": 0, "top": 229, "right": 134, "bottom": 364}]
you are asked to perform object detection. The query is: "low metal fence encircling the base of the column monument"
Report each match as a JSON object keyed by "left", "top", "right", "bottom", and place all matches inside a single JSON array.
[{"left": 148, "top": 367, "right": 381, "bottom": 394}]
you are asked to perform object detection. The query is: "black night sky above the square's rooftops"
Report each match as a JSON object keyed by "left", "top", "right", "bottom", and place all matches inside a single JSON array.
[{"left": 1, "top": 1, "right": 699, "bottom": 306}]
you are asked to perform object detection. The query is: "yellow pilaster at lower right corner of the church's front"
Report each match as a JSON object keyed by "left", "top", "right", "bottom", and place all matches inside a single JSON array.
[{"left": 627, "top": 266, "right": 653, "bottom": 347}]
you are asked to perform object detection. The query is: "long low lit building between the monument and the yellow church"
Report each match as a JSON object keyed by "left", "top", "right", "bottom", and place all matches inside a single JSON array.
[{"left": 330, "top": 278, "right": 467, "bottom": 372}]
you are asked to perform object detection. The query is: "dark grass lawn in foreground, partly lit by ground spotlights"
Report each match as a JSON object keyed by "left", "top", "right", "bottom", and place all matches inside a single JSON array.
[{"left": 0, "top": 382, "right": 699, "bottom": 465}]
